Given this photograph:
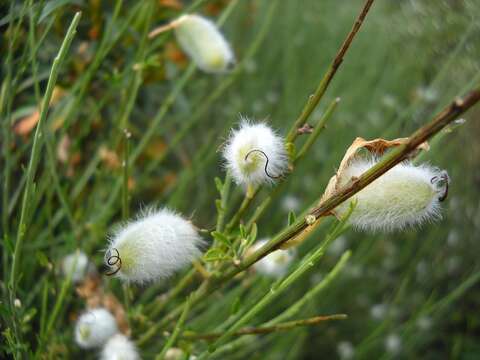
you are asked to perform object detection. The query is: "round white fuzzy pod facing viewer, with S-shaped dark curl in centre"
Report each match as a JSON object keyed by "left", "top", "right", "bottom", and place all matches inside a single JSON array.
[{"left": 223, "top": 119, "right": 288, "bottom": 185}]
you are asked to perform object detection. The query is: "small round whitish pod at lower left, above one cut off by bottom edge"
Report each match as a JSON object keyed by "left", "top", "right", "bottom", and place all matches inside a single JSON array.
[{"left": 75, "top": 308, "right": 118, "bottom": 349}]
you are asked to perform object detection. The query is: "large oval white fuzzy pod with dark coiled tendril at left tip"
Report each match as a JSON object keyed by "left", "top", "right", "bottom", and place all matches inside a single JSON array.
[{"left": 105, "top": 209, "right": 202, "bottom": 283}]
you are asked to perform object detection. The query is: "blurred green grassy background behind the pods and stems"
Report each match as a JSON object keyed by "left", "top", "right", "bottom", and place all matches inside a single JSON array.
[{"left": 0, "top": 0, "right": 480, "bottom": 359}]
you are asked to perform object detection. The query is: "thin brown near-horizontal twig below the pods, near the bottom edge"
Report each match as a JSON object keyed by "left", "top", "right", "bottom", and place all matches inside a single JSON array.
[{"left": 182, "top": 314, "right": 348, "bottom": 340}]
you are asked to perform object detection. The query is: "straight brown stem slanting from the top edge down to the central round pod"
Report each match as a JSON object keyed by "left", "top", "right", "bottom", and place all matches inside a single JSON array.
[{"left": 286, "top": 0, "right": 374, "bottom": 143}]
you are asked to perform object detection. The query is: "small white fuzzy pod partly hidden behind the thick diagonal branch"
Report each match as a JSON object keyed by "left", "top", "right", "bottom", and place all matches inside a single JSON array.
[{"left": 249, "top": 240, "right": 295, "bottom": 279}]
